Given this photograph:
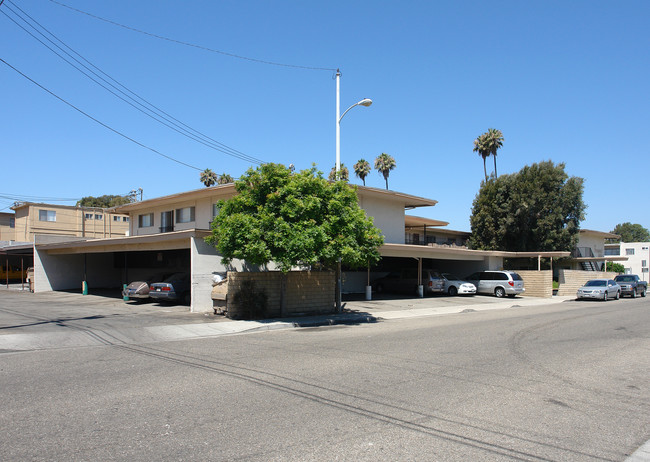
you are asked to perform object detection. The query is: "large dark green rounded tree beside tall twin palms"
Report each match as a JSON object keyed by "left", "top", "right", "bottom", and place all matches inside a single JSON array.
[{"left": 469, "top": 161, "right": 586, "bottom": 251}]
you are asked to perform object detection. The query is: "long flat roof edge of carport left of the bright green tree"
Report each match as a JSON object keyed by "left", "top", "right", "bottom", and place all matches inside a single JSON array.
[{"left": 35, "top": 229, "right": 210, "bottom": 254}]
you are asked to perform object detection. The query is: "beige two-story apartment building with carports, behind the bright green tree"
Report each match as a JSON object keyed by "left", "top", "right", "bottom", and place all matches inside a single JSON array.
[{"left": 30, "top": 184, "right": 569, "bottom": 311}]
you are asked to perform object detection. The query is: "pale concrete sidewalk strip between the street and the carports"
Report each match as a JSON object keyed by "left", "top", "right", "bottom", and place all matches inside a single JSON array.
[{"left": 0, "top": 290, "right": 573, "bottom": 352}]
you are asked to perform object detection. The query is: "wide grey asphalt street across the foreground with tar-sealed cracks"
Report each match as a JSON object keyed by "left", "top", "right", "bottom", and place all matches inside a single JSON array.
[{"left": 0, "top": 290, "right": 650, "bottom": 461}]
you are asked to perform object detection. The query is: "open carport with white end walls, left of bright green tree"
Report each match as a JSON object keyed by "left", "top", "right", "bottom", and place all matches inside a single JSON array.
[{"left": 34, "top": 230, "right": 226, "bottom": 311}]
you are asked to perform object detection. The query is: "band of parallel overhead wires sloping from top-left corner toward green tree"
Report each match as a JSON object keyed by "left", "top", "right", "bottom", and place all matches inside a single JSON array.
[{"left": 0, "top": 1, "right": 264, "bottom": 164}]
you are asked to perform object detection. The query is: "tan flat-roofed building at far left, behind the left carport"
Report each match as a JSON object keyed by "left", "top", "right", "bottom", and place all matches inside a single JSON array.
[{"left": 11, "top": 202, "right": 129, "bottom": 242}]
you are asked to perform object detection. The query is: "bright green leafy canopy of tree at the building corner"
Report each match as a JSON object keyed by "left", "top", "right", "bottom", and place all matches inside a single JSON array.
[{"left": 205, "top": 163, "right": 383, "bottom": 272}]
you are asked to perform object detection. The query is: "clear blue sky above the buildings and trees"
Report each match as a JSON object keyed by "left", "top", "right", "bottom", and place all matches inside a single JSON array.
[{"left": 0, "top": 0, "right": 650, "bottom": 231}]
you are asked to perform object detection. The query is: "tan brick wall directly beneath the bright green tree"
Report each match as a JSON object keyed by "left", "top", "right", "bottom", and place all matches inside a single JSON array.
[{"left": 228, "top": 271, "right": 336, "bottom": 318}]
